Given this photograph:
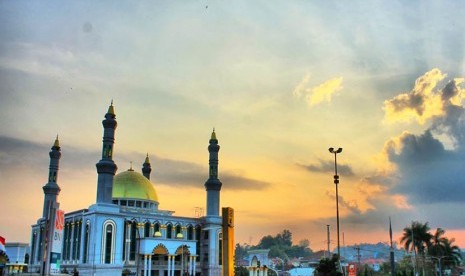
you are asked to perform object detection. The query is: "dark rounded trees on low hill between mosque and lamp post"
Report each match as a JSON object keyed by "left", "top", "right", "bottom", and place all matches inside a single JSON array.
[{"left": 236, "top": 230, "right": 312, "bottom": 260}]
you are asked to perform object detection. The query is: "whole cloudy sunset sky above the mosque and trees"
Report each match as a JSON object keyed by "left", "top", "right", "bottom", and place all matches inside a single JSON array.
[{"left": 0, "top": 0, "right": 465, "bottom": 250}]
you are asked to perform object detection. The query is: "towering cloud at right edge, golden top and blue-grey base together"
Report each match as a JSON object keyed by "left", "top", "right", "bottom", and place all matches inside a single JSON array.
[{"left": 374, "top": 69, "right": 465, "bottom": 204}]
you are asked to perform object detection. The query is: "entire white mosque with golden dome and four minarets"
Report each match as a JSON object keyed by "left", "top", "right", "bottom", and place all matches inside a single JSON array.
[{"left": 29, "top": 103, "right": 226, "bottom": 276}]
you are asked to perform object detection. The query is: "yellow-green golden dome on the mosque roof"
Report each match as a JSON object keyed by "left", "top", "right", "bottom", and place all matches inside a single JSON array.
[{"left": 113, "top": 170, "right": 158, "bottom": 202}]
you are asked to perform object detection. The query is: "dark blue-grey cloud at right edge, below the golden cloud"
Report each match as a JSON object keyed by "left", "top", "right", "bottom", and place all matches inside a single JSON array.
[{"left": 385, "top": 130, "right": 465, "bottom": 203}]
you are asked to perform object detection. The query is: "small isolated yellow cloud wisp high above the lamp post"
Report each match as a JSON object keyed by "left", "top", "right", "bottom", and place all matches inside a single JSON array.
[{"left": 292, "top": 74, "right": 343, "bottom": 106}]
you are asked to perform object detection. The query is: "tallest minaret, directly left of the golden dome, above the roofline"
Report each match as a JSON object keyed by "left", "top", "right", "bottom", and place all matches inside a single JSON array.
[{"left": 96, "top": 101, "right": 118, "bottom": 203}]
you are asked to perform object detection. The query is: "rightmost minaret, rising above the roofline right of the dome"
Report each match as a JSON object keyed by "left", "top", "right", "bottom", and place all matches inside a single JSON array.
[{"left": 205, "top": 129, "right": 222, "bottom": 216}]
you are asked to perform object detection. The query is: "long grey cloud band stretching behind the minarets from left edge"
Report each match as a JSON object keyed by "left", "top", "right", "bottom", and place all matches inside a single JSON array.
[{"left": 0, "top": 136, "right": 270, "bottom": 190}]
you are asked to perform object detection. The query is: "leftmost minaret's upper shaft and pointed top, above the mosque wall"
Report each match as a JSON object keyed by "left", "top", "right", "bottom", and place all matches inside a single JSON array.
[{"left": 42, "top": 135, "right": 61, "bottom": 218}]
